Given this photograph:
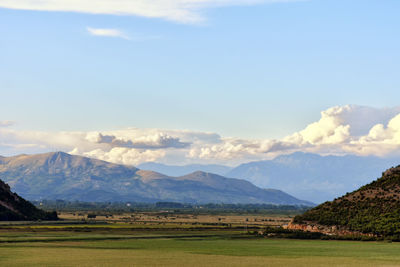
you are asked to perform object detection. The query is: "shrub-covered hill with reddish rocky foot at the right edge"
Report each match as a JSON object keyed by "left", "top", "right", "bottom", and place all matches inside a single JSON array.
[{"left": 293, "top": 166, "right": 400, "bottom": 238}]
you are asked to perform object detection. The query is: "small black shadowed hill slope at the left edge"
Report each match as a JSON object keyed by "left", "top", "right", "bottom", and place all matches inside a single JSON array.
[{"left": 0, "top": 180, "right": 58, "bottom": 221}]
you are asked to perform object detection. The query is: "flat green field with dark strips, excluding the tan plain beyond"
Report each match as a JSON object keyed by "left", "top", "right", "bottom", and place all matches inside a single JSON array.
[{"left": 0, "top": 224, "right": 400, "bottom": 266}]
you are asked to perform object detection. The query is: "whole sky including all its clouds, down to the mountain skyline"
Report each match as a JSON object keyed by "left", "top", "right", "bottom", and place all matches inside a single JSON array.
[{"left": 0, "top": 0, "right": 400, "bottom": 168}]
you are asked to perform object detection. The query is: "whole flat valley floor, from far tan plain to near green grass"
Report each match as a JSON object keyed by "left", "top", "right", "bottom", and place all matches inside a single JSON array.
[{"left": 0, "top": 211, "right": 400, "bottom": 267}]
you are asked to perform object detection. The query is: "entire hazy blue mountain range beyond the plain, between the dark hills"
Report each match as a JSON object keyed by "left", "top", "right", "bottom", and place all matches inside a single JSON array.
[{"left": 0, "top": 152, "right": 400, "bottom": 204}]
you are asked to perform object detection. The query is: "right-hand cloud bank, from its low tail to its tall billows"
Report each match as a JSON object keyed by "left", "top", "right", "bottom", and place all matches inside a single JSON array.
[{"left": 188, "top": 105, "right": 400, "bottom": 161}]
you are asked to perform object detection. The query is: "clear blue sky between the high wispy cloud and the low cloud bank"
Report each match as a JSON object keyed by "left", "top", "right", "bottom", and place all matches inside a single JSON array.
[{"left": 0, "top": 0, "right": 400, "bottom": 165}]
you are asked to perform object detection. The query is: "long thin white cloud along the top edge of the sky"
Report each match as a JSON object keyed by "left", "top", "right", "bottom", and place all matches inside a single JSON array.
[{"left": 0, "top": 0, "right": 297, "bottom": 23}]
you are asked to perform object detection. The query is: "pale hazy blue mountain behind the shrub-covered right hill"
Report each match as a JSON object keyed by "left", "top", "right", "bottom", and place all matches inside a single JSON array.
[{"left": 226, "top": 152, "right": 400, "bottom": 203}]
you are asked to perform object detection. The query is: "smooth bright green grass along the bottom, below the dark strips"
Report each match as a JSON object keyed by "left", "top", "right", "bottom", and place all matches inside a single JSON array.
[{"left": 0, "top": 237, "right": 400, "bottom": 266}]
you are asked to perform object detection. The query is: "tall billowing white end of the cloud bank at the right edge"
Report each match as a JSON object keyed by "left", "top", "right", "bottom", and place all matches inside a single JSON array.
[{"left": 284, "top": 105, "right": 400, "bottom": 156}]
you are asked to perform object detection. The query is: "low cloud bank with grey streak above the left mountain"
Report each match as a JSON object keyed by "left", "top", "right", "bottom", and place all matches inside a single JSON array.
[{"left": 0, "top": 128, "right": 190, "bottom": 165}]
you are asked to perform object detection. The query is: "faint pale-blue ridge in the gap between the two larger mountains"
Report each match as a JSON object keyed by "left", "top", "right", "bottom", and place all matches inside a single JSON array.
[{"left": 137, "top": 162, "right": 233, "bottom": 176}]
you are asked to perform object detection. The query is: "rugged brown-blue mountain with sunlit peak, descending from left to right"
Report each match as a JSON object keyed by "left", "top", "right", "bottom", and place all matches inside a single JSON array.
[{"left": 0, "top": 152, "right": 312, "bottom": 205}]
